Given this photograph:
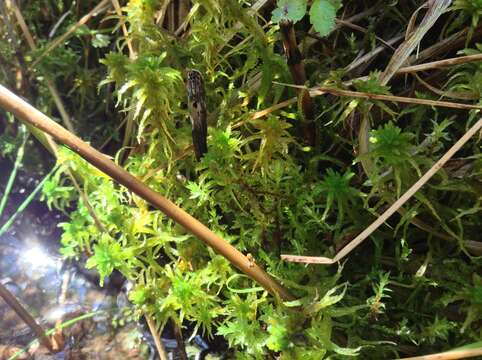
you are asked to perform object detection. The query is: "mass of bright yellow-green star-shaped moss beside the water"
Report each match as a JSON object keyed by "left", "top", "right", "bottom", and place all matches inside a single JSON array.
[{"left": 0, "top": 0, "right": 482, "bottom": 359}]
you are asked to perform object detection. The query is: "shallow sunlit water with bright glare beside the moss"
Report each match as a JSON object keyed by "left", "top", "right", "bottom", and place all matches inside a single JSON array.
[{"left": 0, "top": 235, "right": 219, "bottom": 360}]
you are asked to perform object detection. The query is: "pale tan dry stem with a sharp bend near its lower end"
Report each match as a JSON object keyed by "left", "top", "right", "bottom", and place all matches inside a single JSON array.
[{"left": 281, "top": 118, "right": 482, "bottom": 264}]
